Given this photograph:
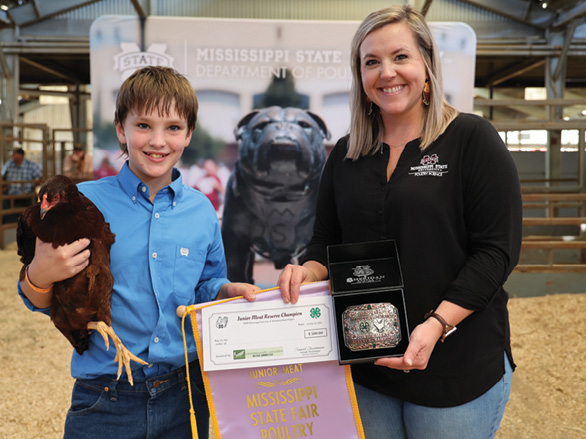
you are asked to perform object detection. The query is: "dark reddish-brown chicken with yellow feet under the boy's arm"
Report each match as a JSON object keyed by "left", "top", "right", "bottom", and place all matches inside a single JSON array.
[{"left": 16, "top": 175, "right": 147, "bottom": 384}]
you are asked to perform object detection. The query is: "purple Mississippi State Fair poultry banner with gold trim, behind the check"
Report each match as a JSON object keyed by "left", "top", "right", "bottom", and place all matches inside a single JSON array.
[{"left": 182, "top": 281, "right": 364, "bottom": 439}]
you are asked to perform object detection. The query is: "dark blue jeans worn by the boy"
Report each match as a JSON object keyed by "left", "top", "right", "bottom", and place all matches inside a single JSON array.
[{"left": 64, "top": 361, "right": 209, "bottom": 439}]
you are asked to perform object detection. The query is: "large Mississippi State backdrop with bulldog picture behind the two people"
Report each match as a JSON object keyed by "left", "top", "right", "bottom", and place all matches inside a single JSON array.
[{"left": 90, "top": 16, "right": 476, "bottom": 287}]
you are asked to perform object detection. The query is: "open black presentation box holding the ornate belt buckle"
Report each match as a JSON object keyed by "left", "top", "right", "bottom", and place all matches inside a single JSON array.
[{"left": 328, "top": 240, "right": 409, "bottom": 364}]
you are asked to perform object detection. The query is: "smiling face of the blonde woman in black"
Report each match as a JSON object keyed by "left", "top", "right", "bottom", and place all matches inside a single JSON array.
[{"left": 360, "top": 23, "right": 426, "bottom": 125}]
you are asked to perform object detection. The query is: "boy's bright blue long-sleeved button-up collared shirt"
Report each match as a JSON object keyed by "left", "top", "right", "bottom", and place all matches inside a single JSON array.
[{"left": 19, "top": 164, "right": 229, "bottom": 379}]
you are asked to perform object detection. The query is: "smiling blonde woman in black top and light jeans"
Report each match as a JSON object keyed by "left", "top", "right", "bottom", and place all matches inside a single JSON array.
[{"left": 279, "top": 5, "right": 522, "bottom": 439}]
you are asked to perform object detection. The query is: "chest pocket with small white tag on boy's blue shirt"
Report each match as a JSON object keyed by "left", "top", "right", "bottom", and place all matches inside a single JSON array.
[{"left": 173, "top": 245, "right": 207, "bottom": 304}]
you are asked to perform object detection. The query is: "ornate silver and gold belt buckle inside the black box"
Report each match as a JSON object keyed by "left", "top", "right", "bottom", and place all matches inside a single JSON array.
[{"left": 342, "top": 302, "right": 401, "bottom": 351}]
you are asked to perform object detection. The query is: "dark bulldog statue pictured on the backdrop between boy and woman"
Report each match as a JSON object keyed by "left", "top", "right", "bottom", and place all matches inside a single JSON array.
[{"left": 222, "top": 106, "right": 330, "bottom": 283}]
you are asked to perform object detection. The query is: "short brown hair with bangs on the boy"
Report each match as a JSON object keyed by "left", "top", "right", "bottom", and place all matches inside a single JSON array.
[{"left": 114, "top": 66, "right": 198, "bottom": 154}]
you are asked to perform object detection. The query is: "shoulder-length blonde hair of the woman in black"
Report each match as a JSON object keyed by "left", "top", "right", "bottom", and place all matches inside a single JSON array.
[{"left": 346, "top": 5, "right": 458, "bottom": 160}]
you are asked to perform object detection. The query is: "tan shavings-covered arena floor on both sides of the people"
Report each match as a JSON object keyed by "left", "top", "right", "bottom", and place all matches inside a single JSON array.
[{"left": 0, "top": 244, "right": 586, "bottom": 439}]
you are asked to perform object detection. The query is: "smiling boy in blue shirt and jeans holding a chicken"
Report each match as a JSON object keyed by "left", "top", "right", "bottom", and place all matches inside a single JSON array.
[{"left": 19, "top": 67, "right": 259, "bottom": 439}]
